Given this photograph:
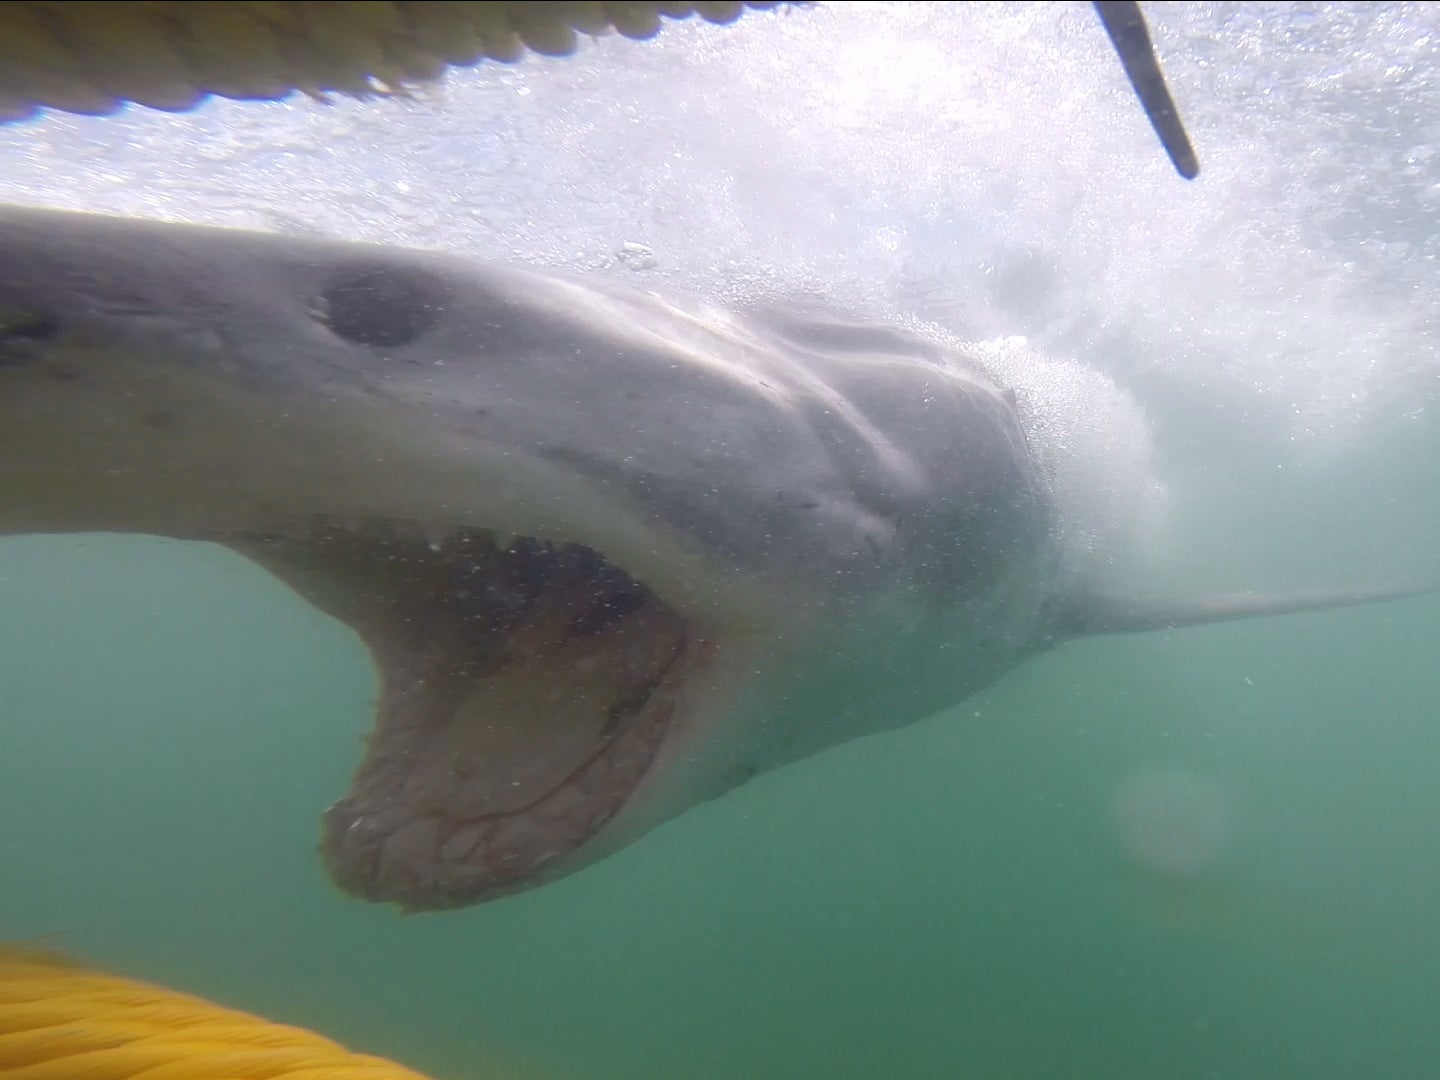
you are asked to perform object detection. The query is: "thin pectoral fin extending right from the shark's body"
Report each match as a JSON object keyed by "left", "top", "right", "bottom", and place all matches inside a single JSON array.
[{"left": 1054, "top": 586, "right": 1440, "bottom": 641}]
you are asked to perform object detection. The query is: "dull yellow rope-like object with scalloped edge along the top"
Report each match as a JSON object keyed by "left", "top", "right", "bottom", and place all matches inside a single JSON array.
[{"left": 0, "top": 0, "right": 778, "bottom": 122}]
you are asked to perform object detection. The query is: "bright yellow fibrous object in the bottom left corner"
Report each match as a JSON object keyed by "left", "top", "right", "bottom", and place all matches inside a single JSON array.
[{"left": 0, "top": 946, "right": 437, "bottom": 1080}]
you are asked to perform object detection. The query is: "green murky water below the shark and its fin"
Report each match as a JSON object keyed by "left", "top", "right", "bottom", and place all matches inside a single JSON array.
[{"left": 0, "top": 518, "right": 1440, "bottom": 1080}]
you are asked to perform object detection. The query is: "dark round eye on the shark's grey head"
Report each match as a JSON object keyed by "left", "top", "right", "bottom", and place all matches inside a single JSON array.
[{"left": 312, "top": 266, "right": 445, "bottom": 348}]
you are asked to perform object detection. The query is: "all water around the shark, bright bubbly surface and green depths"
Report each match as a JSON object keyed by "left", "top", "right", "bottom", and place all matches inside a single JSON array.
[{"left": 0, "top": 3, "right": 1440, "bottom": 1080}]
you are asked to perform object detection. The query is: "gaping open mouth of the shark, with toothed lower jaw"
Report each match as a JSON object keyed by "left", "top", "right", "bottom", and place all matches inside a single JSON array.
[{"left": 225, "top": 520, "right": 696, "bottom": 910}]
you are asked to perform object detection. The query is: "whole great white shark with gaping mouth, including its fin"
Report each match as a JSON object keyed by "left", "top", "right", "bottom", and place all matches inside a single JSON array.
[{"left": 0, "top": 207, "right": 1413, "bottom": 910}]
